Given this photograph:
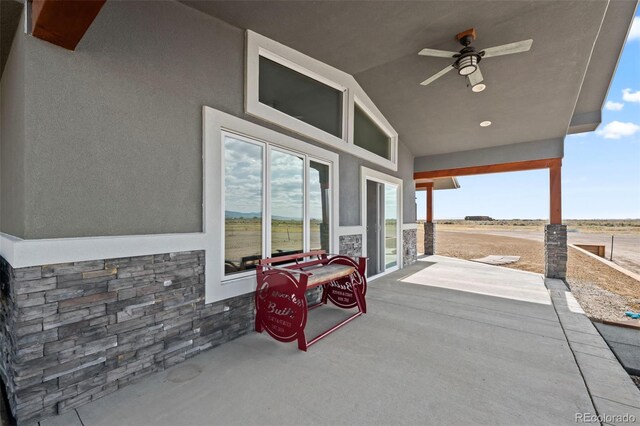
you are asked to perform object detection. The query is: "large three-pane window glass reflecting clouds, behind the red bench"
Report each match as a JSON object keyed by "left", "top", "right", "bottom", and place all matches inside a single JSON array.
[{"left": 222, "top": 132, "right": 331, "bottom": 276}]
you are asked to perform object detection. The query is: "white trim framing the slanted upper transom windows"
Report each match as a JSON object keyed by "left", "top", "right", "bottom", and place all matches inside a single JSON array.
[{"left": 245, "top": 30, "right": 398, "bottom": 171}]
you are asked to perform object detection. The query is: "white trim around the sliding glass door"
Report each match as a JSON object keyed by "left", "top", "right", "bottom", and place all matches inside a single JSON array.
[{"left": 360, "top": 166, "right": 404, "bottom": 278}]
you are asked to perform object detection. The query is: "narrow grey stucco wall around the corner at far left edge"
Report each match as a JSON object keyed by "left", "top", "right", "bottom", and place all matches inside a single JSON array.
[{"left": 0, "top": 10, "right": 25, "bottom": 235}]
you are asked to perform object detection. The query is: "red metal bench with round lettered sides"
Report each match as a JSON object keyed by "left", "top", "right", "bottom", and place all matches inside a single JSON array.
[{"left": 255, "top": 250, "right": 367, "bottom": 351}]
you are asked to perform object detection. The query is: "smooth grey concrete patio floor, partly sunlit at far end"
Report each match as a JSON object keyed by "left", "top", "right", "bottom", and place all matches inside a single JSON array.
[{"left": 41, "top": 256, "right": 640, "bottom": 426}]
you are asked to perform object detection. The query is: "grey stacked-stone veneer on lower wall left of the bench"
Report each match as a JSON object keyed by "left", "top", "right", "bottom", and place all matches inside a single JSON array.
[{"left": 0, "top": 251, "right": 254, "bottom": 424}]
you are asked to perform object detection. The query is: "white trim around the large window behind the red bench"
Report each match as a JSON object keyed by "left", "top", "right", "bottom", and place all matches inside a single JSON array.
[{"left": 208, "top": 107, "right": 339, "bottom": 303}]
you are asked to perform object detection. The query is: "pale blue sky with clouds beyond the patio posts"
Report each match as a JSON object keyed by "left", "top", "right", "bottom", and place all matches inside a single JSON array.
[{"left": 416, "top": 13, "right": 640, "bottom": 219}]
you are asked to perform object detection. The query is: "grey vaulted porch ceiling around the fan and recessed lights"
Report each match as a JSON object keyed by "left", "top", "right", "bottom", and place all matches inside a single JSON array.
[{"left": 184, "top": 0, "right": 636, "bottom": 156}]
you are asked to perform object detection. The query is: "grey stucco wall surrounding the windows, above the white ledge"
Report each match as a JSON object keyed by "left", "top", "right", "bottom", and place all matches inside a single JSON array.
[{"left": 3, "top": 1, "right": 415, "bottom": 239}]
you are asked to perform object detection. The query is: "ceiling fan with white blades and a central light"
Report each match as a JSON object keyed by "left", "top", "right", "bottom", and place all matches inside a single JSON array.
[{"left": 418, "top": 28, "right": 533, "bottom": 92}]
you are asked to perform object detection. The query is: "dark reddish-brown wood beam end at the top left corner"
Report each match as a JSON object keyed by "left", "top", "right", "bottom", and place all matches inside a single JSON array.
[{"left": 31, "top": 0, "right": 106, "bottom": 50}]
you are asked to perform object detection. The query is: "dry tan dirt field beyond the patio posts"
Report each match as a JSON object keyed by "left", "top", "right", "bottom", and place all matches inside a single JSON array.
[{"left": 418, "top": 224, "right": 640, "bottom": 320}]
